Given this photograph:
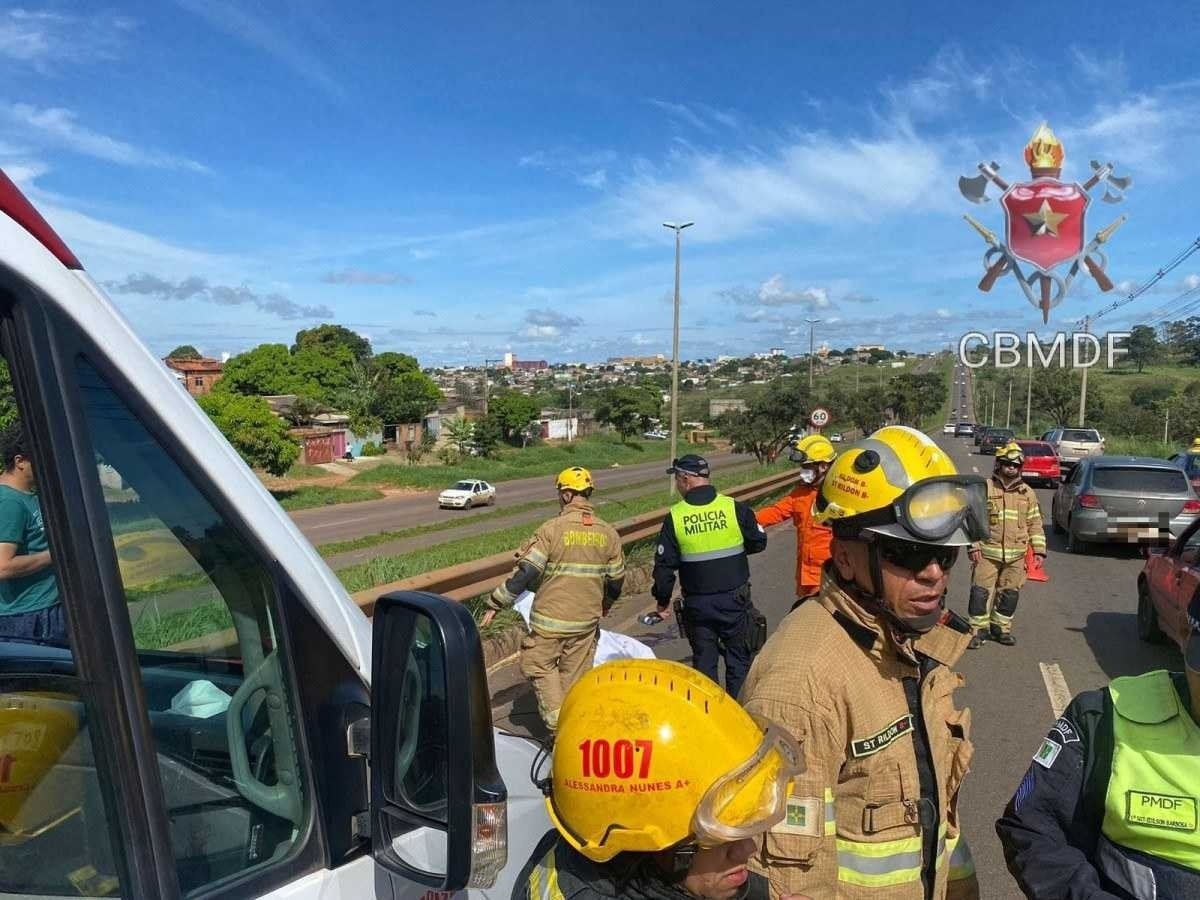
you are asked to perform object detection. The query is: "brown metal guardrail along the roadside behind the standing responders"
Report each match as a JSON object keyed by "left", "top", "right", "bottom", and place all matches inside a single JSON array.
[{"left": 350, "top": 469, "right": 799, "bottom": 616}]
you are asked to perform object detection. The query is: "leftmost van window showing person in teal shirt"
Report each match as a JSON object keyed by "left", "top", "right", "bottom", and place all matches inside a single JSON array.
[{"left": 0, "top": 358, "right": 120, "bottom": 896}]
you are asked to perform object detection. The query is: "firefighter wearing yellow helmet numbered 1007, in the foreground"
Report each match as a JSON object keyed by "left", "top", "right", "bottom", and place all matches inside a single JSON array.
[{"left": 514, "top": 660, "right": 803, "bottom": 900}]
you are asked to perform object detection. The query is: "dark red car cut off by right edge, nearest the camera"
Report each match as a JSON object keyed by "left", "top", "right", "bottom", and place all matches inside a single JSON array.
[{"left": 1138, "top": 520, "right": 1200, "bottom": 649}]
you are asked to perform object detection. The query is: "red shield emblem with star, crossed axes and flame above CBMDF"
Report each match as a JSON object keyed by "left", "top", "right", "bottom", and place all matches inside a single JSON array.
[{"left": 959, "top": 122, "right": 1133, "bottom": 322}]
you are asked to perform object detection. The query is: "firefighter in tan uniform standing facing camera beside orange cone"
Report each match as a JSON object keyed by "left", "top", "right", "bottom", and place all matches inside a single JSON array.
[{"left": 967, "top": 442, "right": 1046, "bottom": 650}]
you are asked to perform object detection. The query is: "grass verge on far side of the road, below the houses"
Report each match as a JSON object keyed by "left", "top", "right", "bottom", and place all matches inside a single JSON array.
[{"left": 347, "top": 434, "right": 708, "bottom": 488}]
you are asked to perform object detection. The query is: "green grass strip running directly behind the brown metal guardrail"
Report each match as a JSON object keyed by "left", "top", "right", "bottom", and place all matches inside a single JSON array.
[{"left": 337, "top": 466, "right": 784, "bottom": 593}]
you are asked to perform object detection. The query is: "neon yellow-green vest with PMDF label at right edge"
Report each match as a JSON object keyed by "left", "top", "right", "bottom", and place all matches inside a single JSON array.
[{"left": 1098, "top": 671, "right": 1200, "bottom": 883}]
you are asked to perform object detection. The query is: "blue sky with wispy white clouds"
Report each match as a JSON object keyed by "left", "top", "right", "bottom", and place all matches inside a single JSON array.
[{"left": 0, "top": 0, "right": 1200, "bottom": 364}]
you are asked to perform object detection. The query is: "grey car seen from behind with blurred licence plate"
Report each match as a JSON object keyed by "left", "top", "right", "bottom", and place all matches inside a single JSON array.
[{"left": 1050, "top": 456, "right": 1200, "bottom": 553}]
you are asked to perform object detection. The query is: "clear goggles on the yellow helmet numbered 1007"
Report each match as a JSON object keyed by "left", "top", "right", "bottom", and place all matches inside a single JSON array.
[{"left": 691, "top": 720, "right": 803, "bottom": 846}]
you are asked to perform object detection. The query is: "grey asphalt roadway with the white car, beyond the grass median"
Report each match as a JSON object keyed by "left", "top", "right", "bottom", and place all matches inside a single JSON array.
[{"left": 292, "top": 454, "right": 745, "bottom": 546}]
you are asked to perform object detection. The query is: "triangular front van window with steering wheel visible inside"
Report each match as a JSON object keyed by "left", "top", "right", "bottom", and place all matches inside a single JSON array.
[{"left": 77, "top": 360, "right": 311, "bottom": 894}]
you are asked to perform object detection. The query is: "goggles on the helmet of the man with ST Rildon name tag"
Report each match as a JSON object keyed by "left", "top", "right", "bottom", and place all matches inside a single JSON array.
[{"left": 835, "top": 475, "right": 989, "bottom": 542}]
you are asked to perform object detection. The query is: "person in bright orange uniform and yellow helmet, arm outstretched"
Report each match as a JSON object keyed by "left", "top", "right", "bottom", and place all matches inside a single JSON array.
[{"left": 755, "top": 434, "right": 838, "bottom": 600}]
